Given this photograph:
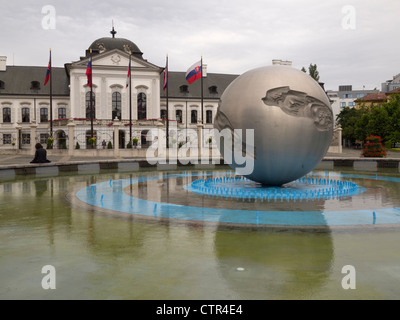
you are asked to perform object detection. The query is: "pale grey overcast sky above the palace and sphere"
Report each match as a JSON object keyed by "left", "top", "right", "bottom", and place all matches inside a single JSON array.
[{"left": 0, "top": 0, "right": 400, "bottom": 90}]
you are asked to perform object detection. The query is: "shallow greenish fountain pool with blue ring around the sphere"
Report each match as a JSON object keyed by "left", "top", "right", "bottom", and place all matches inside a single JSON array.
[{"left": 0, "top": 168, "right": 400, "bottom": 300}]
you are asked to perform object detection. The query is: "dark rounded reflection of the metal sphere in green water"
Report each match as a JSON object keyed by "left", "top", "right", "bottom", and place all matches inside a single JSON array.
[{"left": 215, "top": 231, "right": 334, "bottom": 299}]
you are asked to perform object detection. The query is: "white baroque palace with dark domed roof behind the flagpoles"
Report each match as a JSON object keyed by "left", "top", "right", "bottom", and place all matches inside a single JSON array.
[{"left": 0, "top": 30, "right": 237, "bottom": 151}]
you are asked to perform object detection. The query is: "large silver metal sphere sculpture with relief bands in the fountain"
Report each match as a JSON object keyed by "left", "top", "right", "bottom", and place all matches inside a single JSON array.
[{"left": 214, "top": 66, "right": 333, "bottom": 186}]
